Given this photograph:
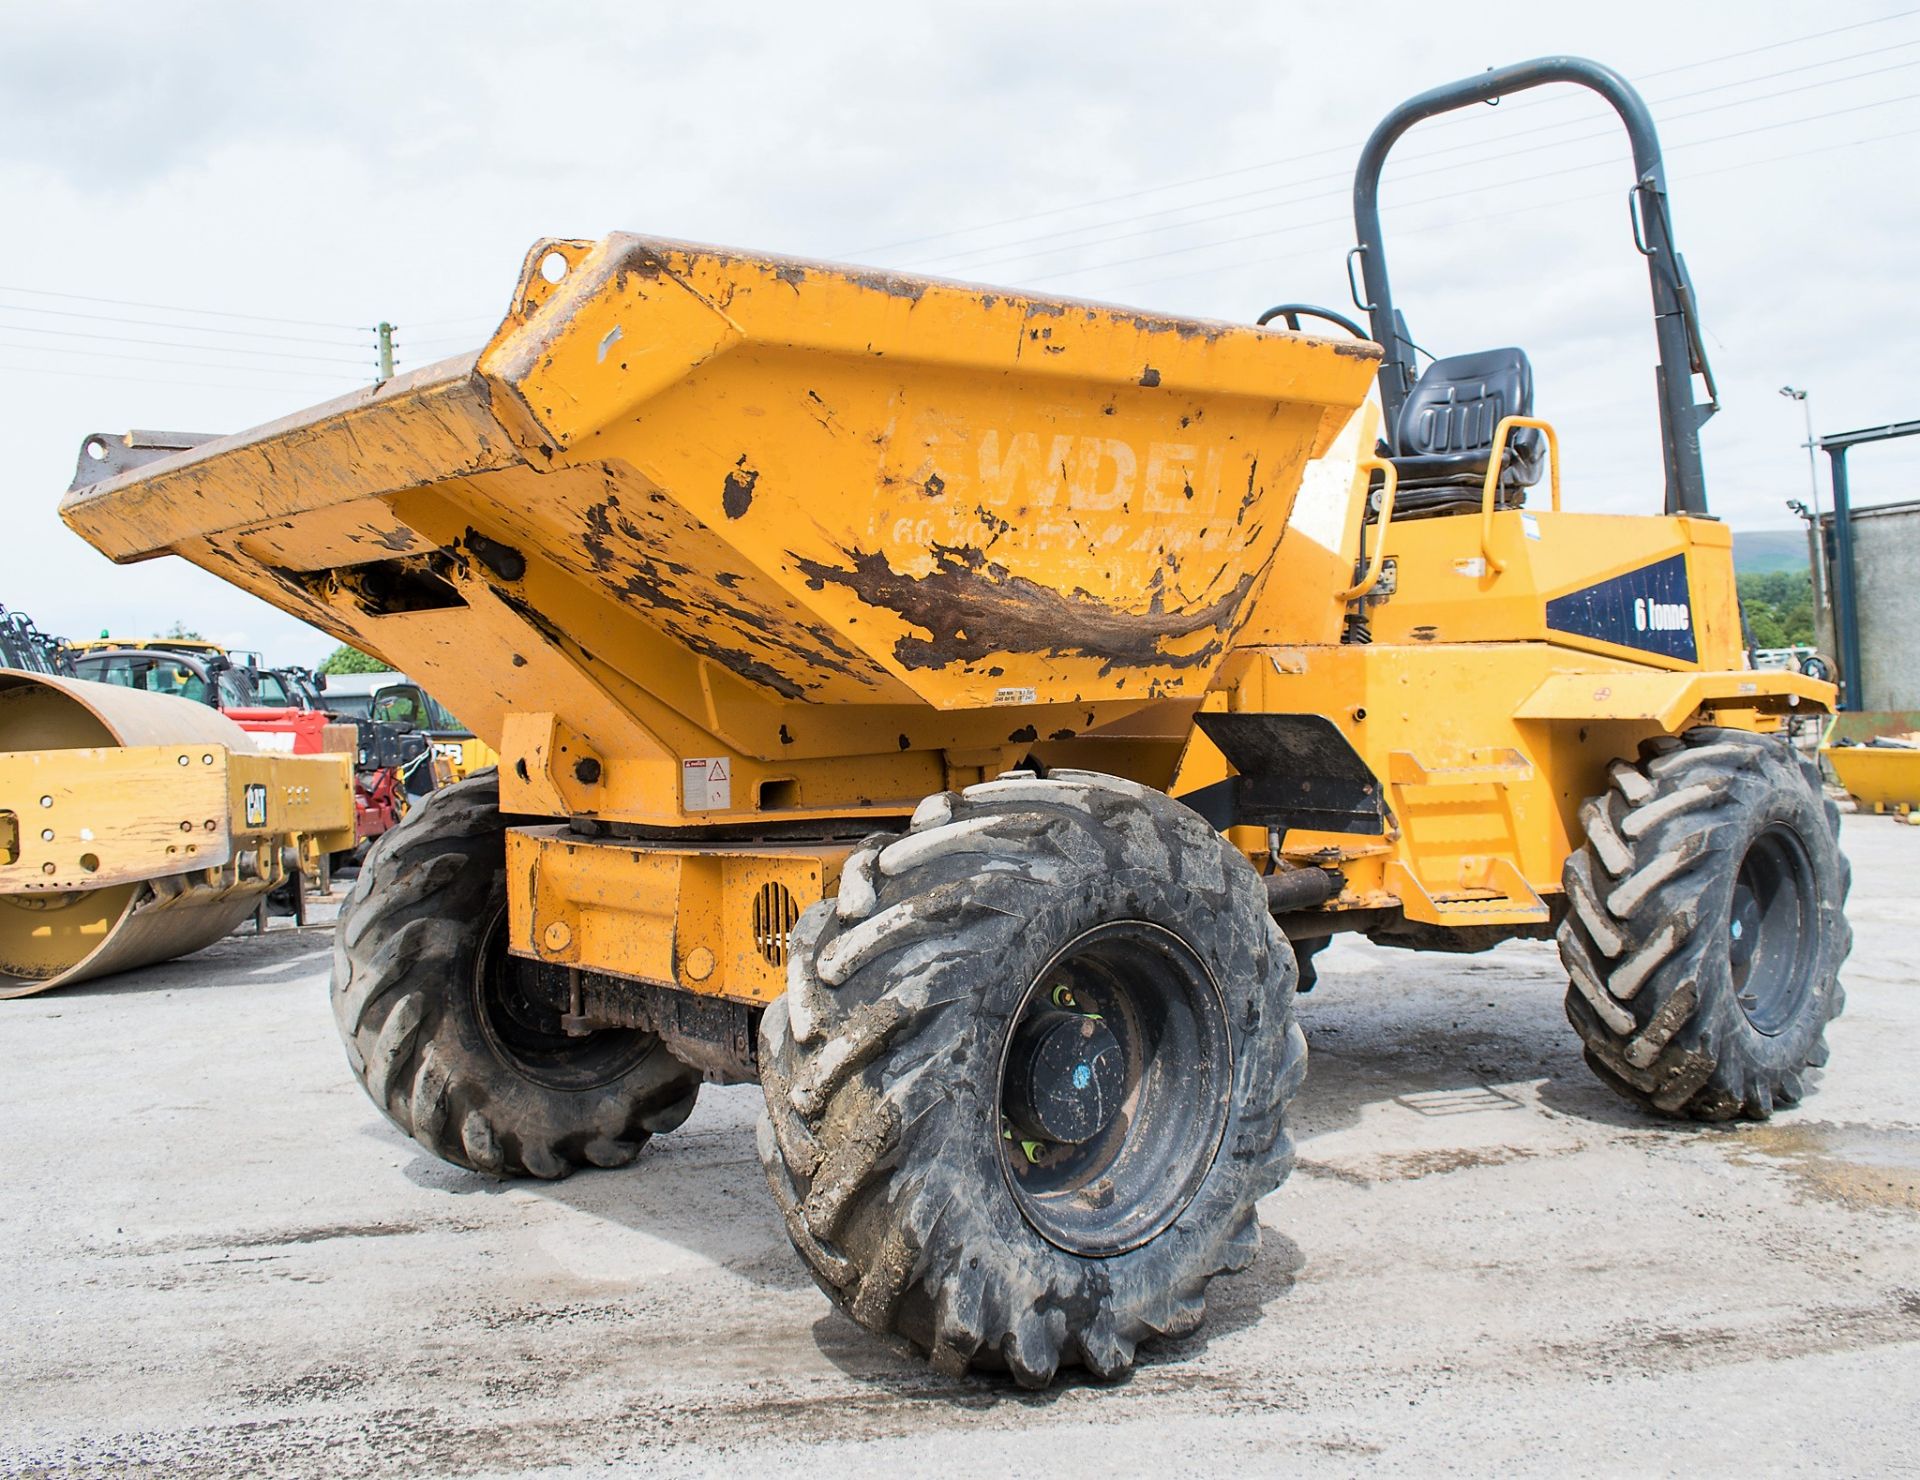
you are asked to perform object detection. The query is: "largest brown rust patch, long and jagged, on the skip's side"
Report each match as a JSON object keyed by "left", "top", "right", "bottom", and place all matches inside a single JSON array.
[{"left": 789, "top": 545, "right": 1254, "bottom": 676}]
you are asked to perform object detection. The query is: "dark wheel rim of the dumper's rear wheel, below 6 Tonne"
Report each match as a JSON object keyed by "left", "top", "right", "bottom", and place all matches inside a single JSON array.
[{"left": 1726, "top": 824, "right": 1816, "bottom": 1037}]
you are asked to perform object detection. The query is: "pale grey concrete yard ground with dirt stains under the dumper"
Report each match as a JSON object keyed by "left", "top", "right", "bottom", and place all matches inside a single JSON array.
[{"left": 0, "top": 816, "right": 1920, "bottom": 1478}]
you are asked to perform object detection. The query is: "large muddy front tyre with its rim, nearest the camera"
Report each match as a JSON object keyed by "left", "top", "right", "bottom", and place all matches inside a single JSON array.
[{"left": 760, "top": 772, "right": 1306, "bottom": 1386}]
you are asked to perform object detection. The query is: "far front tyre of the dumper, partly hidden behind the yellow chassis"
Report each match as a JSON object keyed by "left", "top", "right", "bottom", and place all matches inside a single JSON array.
[{"left": 332, "top": 772, "right": 699, "bottom": 1177}]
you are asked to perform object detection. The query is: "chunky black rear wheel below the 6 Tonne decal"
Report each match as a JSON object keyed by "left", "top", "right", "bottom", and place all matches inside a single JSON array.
[{"left": 1559, "top": 728, "right": 1853, "bottom": 1121}]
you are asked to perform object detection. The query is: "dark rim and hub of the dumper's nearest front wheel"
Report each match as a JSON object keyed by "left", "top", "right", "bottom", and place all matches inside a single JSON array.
[{"left": 996, "top": 919, "right": 1233, "bottom": 1257}]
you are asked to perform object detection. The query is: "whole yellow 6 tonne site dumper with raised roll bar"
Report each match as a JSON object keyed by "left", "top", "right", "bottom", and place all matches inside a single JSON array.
[{"left": 63, "top": 58, "right": 1849, "bottom": 1384}]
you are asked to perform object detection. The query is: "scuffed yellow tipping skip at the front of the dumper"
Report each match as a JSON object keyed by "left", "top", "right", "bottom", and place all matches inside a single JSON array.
[{"left": 61, "top": 236, "right": 1379, "bottom": 754}]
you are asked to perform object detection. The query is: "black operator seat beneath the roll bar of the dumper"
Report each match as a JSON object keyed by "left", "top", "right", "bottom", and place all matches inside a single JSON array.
[{"left": 1380, "top": 347, "right": 1546, "bottom": 514}]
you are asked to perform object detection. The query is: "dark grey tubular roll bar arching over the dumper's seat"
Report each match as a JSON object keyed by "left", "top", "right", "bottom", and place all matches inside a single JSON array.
[{"left": 1348, "top": 56, "right": 1720, "bottom": 514}]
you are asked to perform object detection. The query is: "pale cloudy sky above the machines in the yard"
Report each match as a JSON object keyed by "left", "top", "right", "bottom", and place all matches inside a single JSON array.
[{"left": 0, "top": 0, "right": 1920, "bottom": 660}]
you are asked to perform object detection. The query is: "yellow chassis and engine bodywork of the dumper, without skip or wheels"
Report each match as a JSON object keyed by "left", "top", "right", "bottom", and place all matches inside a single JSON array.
[{"left": 503, "top": 479, "right": 1834, "bottom": 1004}]
